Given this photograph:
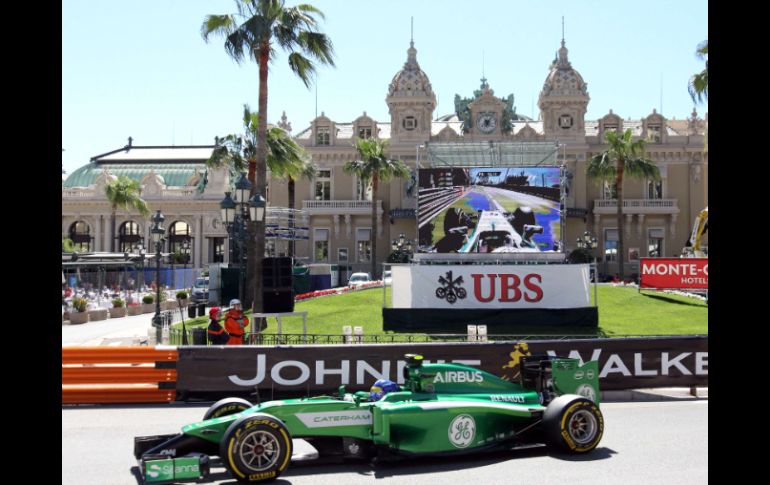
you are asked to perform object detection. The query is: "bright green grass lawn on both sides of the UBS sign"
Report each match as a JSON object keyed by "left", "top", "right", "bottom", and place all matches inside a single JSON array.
[{"left": 174, "top": 285, "right": 708, "bottom": 337}]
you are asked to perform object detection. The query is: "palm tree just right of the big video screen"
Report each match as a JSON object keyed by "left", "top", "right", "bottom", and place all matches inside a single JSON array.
[{"left": 587, "top": 129, "right": 660, "bottom": 281}]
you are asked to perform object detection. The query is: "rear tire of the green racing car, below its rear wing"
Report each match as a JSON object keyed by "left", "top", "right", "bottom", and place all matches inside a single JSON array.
[{"left": 542, "top": 394, "right": 604, "bottom": 454}]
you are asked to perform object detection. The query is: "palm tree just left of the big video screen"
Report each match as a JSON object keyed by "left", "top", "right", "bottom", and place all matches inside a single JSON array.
[{"left": 343, "top": 138, "right": 409, "bottom": 278}]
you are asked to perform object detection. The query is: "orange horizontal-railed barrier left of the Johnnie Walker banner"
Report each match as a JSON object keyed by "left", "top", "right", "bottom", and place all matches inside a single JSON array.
[{"left": 62, "top": 346, "right": 179, "bottom": 404}]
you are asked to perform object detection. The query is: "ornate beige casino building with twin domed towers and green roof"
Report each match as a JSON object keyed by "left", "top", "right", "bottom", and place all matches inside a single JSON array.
[{"left": 62, "top": 35, "right": 708, "bottom": 282}]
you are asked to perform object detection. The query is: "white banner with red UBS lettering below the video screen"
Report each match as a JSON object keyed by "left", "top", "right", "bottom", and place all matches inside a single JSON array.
[{"left": 392, "top": 264, "right": 590, "bottom": 310}]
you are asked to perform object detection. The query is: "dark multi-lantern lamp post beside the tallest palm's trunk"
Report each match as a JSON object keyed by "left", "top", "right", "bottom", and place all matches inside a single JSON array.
[{"left": 219, "top": 172, "right": 266, "bottom": 301}]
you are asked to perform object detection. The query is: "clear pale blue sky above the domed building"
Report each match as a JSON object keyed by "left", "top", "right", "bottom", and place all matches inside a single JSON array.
[{"left": 62, "top": 0, "right": 708, "bottom": 173}]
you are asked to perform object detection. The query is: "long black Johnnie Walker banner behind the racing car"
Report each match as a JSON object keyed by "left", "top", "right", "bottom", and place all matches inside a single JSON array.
[{"left": 177, "top": 336, "right": 708, "bottom": 396}]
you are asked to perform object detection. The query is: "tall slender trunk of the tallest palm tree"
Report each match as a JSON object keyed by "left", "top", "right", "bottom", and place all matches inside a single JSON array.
[{"left": 251, "top": 41, "right": 270, "bottom": 314}]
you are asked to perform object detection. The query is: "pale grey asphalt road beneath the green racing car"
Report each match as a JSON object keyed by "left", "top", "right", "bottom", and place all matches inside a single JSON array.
[{"left": 62, "top": 400, "right": 708, "bottom": 485}]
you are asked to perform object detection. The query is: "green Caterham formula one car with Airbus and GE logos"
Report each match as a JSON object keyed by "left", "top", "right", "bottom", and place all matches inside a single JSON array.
[{"left": 134, "top": 355, "right": 604, "bottom": 483}]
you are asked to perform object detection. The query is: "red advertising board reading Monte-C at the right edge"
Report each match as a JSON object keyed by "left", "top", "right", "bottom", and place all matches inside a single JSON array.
[{"left": 639, "top": 258, "right": 709, "bottom": 290}]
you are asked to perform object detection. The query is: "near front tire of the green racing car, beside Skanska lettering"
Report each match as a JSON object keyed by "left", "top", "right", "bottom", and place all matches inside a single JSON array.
[{"left": 219, "top": 413, "right": 292, "bottom": 483}]
